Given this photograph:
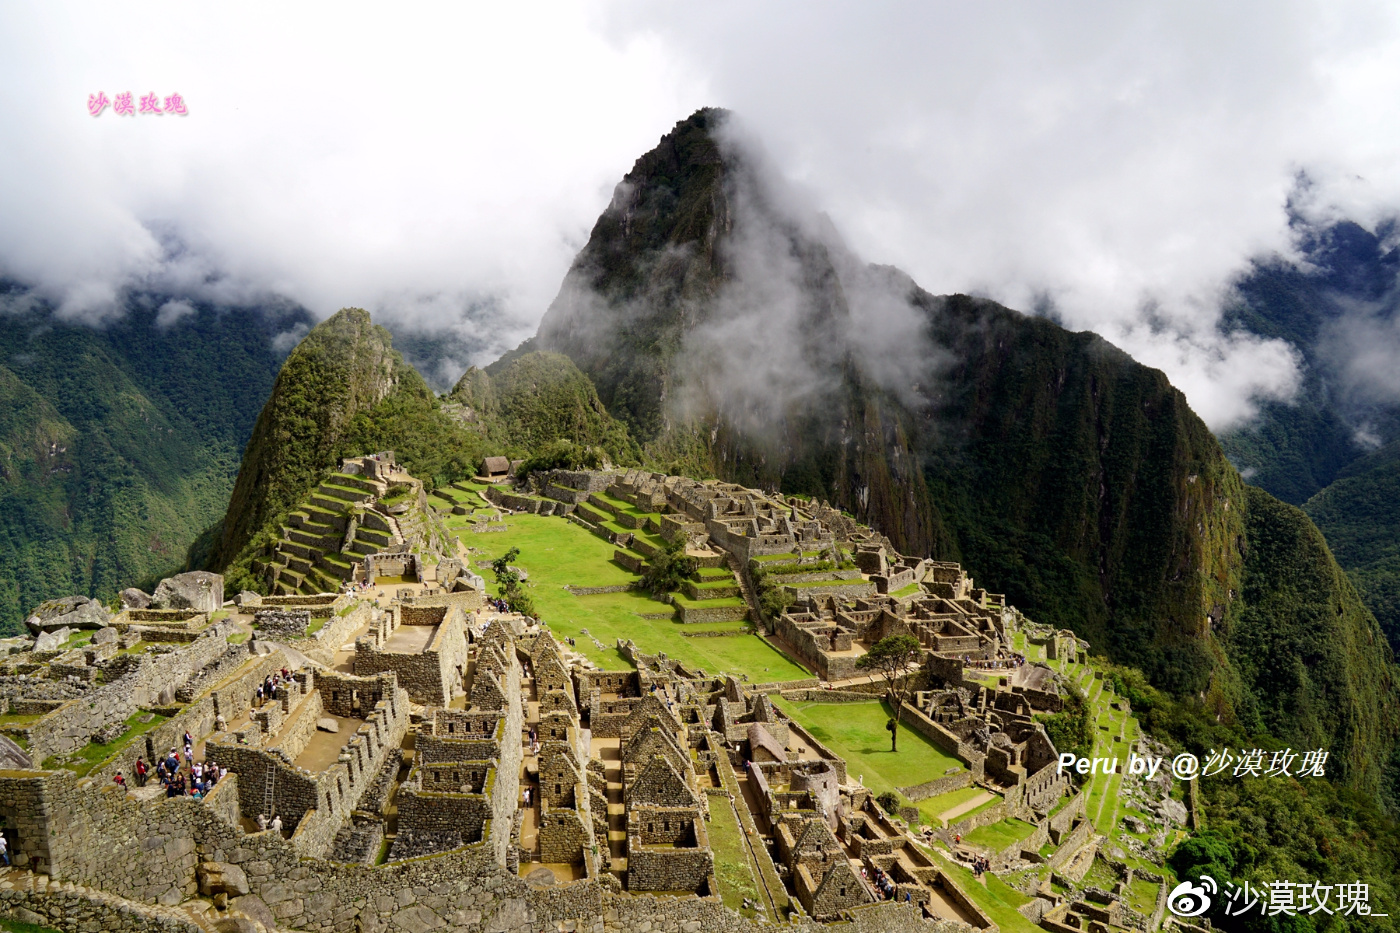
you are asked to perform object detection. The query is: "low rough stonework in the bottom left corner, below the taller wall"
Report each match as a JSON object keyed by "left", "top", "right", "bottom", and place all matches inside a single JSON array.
[{"left": 0, "top": 867, "right": 279, "bottom": 933}]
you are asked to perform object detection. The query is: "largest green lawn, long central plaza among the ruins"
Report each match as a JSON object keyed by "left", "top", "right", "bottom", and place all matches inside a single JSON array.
[{"left": 448, "top": 514, "right": 809, "bottom": 684}]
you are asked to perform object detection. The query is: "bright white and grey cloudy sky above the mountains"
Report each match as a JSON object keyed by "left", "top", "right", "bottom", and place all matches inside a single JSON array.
[{"left": 0, "top": 3, "right": 1400, "bottom": 430}]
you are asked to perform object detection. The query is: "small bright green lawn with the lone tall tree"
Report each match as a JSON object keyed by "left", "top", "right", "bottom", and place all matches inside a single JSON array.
[{"left": 767, "top": 694, "right": 963, "bottom": 794}]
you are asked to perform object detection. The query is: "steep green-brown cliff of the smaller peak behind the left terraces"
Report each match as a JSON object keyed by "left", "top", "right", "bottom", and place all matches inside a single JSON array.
[{"left": 210, "top": 308, "right": 400, "bottom": 569}]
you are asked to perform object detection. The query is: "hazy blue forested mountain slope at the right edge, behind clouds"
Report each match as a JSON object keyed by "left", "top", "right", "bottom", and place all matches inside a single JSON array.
[{"left": 1221, "top": 219, "right": 1400, "bottom": 646}]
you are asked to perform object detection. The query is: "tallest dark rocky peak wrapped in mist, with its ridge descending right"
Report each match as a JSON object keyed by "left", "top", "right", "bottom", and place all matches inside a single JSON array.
[{"left": 522, "top": 111, "right": 1394, "bottom": 782}]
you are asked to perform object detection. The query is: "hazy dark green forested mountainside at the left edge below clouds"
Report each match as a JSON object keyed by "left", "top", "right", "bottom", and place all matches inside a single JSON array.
[{"left": 0, "top": 292, "right": 295, "bottom": 635}]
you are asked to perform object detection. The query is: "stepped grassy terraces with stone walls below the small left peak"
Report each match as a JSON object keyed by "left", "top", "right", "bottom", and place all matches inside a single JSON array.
[{"left": 262, "top": 474, "right": 403, "bottom": 595}]
